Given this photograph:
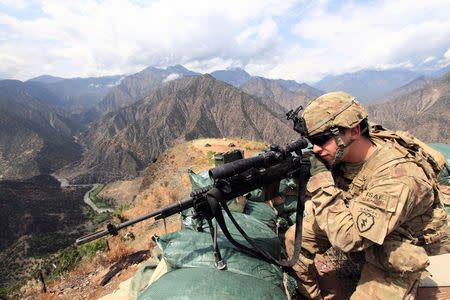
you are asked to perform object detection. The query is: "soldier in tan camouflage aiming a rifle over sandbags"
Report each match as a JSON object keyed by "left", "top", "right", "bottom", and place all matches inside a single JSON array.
[{"left": 286, "top": 92, "right": 450, "bottom": 299}]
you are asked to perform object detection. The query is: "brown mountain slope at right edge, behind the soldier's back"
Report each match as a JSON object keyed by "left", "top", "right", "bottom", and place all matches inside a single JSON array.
[{"left": 367, "top": 72, "right": 450, "bottom": 144}]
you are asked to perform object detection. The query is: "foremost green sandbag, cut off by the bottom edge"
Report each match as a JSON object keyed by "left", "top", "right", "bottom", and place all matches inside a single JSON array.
[{"left": 139, "top": 268, "right": 287, "bottom": 300}]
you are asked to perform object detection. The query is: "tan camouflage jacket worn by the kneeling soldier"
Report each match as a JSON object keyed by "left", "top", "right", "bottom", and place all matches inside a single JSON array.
[{"left": 307, "top": 134, "right": 448, "bottom": 271}]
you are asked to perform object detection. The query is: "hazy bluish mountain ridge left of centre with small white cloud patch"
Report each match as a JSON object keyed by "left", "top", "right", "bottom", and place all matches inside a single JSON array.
[{"left": 82, "top": 65, "right": 197, "bottom": 123}]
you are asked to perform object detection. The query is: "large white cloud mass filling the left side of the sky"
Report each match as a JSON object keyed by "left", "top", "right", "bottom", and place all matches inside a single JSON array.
[{"left": 0, "top": 0, "right": 295, "bottom": 78}]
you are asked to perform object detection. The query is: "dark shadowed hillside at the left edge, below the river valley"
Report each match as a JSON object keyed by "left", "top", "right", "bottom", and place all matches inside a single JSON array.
[{"left": 0, "top": 175, "right": 93, "bottom": 298}]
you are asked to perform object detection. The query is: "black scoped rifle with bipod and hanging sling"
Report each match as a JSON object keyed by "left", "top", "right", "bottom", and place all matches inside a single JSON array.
[{"left": 76, "top": 138, "right": 309, "bottom": 268}]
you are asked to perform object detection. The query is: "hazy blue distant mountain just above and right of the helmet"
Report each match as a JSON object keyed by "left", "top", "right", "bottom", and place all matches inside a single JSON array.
[{"left": 314, "top": 70, "right": 420, "bottom": 103}]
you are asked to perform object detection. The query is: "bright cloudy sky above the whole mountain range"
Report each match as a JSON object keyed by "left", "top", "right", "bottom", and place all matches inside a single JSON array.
[{"left": 0, "top": 0, "right": 450, "bottom": 83}]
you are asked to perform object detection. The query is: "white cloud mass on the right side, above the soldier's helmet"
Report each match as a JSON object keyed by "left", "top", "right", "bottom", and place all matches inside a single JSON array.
[{"left": 282, "top": 0, "right": 450, "bottom": 78}]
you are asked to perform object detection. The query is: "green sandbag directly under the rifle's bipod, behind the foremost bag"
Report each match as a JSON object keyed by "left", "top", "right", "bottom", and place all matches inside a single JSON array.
[{"left": 156, "top": 230, "right": 283, "bottom": 286}]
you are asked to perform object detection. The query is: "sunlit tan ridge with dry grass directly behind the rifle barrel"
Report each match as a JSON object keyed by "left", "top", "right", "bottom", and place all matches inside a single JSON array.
[{"left": 7, "top": 139, "right": 268, "bottom": 299}]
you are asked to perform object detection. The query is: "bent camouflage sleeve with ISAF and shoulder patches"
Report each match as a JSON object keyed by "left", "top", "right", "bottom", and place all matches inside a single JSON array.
[{"left": 307, "top": 168, "right": 433, "bottom": 252}]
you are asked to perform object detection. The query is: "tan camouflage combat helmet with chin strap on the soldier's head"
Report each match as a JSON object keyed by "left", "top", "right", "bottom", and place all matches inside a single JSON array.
[{"left": 303, "top": 92, "right": 367, "bottom": 162}]
